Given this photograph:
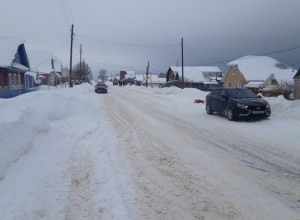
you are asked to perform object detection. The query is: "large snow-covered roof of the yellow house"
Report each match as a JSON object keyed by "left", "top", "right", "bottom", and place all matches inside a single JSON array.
[{"left": 227, "top": 56, "right": 295, "bottom": 82}]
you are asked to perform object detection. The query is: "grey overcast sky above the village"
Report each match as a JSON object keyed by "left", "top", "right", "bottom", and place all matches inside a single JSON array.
[{"left": 0, "top": 0, "right": 300, "bottom": 74}]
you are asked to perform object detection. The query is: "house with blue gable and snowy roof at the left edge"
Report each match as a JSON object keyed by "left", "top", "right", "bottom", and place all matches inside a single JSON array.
[{"left": 0, "top": 37, "right": 30, "bottom": 98}]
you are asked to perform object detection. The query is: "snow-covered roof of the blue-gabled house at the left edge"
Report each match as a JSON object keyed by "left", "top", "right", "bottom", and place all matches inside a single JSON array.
[{"left": 0, "top": 37, "right": 28, "bottom": 70}]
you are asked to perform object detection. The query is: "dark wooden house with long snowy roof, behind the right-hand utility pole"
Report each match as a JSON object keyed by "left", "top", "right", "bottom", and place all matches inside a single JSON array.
[{"left": 166, "top": 66, "right": 222, "bottom": 91}]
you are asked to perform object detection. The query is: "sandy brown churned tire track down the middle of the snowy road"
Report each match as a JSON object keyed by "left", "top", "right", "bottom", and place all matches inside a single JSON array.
[{"left": 105, "top": 88, "right": 238, "bottom": 219}]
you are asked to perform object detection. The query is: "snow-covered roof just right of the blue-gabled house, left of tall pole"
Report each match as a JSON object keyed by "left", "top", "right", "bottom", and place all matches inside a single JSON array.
[{"left": 27, "top": 51, "right": 62, "bottom": 73}]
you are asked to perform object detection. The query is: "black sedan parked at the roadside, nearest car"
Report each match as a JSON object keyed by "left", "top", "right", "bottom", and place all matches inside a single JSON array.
[{"left": 206, "top": 87, "right": 271, "bottom": 121}]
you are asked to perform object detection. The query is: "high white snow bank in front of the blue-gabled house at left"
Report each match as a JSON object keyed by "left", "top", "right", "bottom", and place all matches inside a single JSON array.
[{"left": 0, "top": 86, "right": 92, "bottom": 180}]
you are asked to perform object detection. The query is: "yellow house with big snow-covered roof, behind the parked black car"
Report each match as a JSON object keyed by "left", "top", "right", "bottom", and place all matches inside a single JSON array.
[{"left": 222, "top": 56, "right": 294, "bottom": 96}]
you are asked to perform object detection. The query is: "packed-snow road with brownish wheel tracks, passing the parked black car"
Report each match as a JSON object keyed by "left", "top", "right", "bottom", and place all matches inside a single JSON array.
[{"left": 104, "top": 87, "right": 300, "bottom": 219}]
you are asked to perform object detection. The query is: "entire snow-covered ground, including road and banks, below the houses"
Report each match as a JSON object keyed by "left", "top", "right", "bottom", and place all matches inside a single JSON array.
[{"left": 0, "top": 84, "right": 300, "bottom": 219}]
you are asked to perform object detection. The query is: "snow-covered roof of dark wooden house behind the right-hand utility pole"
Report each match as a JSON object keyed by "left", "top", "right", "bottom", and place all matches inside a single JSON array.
[{"left": 170, "top": 66, "right": 222, "bottom": 82}]
